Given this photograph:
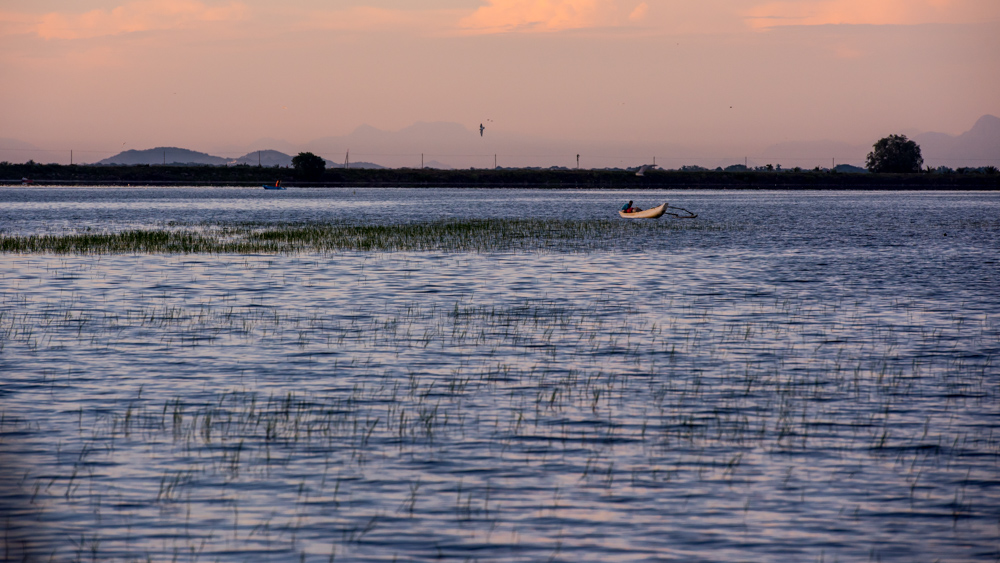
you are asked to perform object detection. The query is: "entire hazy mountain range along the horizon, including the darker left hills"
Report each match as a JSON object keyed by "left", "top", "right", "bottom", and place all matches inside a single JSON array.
[{"left": 0, "top": 115, "right": 1000, "bottom": 169}]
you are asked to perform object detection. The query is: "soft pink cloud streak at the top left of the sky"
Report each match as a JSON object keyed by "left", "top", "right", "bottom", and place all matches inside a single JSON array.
[{"left": 31, "top": 0, "right": 246, "bottom": 39}]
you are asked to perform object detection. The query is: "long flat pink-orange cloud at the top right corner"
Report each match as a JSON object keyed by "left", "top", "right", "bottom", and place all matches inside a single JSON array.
[{"left": 746, "top": 0, "right": 1000, "bottom": 29}]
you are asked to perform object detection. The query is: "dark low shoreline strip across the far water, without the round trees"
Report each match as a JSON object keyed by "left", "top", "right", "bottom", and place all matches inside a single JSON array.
[{"left": 0, "top": 164, "right": 1000, "bottom": 191}]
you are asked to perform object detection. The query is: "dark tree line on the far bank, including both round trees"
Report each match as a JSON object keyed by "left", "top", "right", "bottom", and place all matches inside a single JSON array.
[{"left": 0, "top": 135, "right": 1000, "bottom": 189}]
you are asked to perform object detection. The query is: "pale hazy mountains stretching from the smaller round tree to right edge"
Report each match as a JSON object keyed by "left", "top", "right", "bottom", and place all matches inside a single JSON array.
[{"left": 305, "top": 115, "right": 1000, "bottom": 169}]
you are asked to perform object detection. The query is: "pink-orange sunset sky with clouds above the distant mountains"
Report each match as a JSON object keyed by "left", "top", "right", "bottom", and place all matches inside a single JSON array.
[{"left": 0, "top": 0, "right": 1000, "bottom": 166}]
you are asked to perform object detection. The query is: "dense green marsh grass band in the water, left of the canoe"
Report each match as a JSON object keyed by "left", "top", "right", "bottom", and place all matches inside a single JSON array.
[{"left": 0, "top": 219, "right": 721, "bottom": 254}]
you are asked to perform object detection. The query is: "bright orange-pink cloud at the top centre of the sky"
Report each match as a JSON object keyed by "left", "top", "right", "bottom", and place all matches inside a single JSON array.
[{"left": 459, "top": 0, "right": 648, "bottom": 33}]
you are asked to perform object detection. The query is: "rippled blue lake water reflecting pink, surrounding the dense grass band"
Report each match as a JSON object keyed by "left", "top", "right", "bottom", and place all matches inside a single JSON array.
[{"left": 0, "top": 187, "right": 1000, "bottom": 563}]
